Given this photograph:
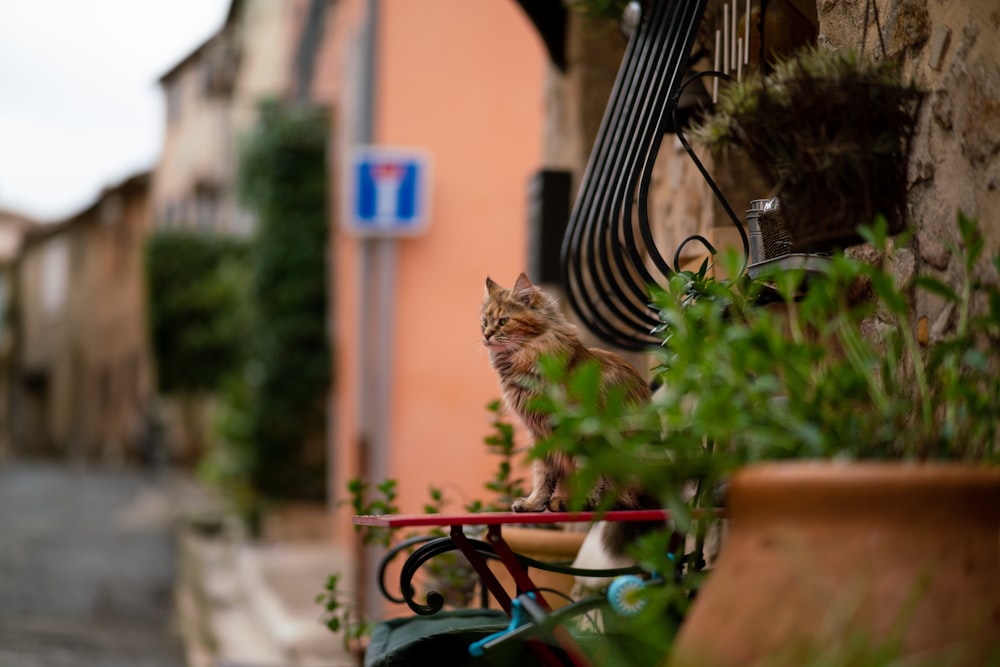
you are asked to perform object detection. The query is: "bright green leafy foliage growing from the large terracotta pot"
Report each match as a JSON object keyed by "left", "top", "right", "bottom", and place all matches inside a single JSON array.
[{"left": 533, "top": 214, "right": 1000, "bottom": 652}]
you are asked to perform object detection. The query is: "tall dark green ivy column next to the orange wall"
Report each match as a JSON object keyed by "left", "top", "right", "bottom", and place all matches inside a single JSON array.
[{"left": 228, "top": 103, "right": 330, "bottom": 498}]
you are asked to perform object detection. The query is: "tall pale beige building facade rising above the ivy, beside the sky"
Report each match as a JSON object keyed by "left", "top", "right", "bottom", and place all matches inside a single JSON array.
[{"left": 153, "top": 0, "right": 308, "bottom": 236}]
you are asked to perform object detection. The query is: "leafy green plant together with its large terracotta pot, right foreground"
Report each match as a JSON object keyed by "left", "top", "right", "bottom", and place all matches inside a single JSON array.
[{"left": 537, "top": 215, "right": 1000, "bottom": 666}]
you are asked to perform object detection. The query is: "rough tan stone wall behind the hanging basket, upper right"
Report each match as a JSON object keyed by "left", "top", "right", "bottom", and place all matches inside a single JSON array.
[{"left": 819, "top": 0, "right": 1000, "bottom": 339}]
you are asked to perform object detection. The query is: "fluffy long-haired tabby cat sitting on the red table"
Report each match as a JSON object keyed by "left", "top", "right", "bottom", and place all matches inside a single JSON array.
[{"left": 482, "top": 273, "right": 656, "bottom": 552}]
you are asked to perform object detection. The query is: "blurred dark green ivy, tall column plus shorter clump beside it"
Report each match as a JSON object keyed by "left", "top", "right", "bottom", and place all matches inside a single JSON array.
[{"left": 146, "top": 99, "right": 330, "bottom": 508}]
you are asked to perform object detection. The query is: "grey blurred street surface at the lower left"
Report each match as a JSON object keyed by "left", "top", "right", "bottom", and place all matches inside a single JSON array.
[{"left": 0, "top": 463, "right": 207, "bottom": 667}]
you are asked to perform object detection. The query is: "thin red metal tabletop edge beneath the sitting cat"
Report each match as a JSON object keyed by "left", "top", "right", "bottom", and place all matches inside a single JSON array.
[{"left": 353, "top": 510, "right": 704, "bottom": 528}]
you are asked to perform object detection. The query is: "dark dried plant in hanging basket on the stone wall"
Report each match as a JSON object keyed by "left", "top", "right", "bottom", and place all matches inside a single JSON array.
[{"left": 695, "top": 48, "right": 923, "bottom": 252}]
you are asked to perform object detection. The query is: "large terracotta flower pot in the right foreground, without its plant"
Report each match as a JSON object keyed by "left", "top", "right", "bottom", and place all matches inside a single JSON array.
[{"left": 670, "top": 463, "right": 1000, "bottom": 667}]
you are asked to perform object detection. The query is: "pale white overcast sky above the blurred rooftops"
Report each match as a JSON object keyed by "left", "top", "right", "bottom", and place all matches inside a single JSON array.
[{"left": 0, "top": 0, "right": 230, "bottom": 221}]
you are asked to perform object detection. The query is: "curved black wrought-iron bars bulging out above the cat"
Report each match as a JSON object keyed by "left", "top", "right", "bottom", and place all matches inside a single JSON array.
[{"left": 562, "top": 0, "right": 749, "bottom": 350}]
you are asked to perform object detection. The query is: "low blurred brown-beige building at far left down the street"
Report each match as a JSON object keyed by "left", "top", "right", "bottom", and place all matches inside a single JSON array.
[{"left": 11, "top": 173, "right": 151, "bottom": 461}]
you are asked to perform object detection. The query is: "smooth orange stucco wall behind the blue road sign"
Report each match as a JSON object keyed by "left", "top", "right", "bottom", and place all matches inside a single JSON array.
[{"left": 325, "top": 0, "right": 546, "bottom": 536}]
